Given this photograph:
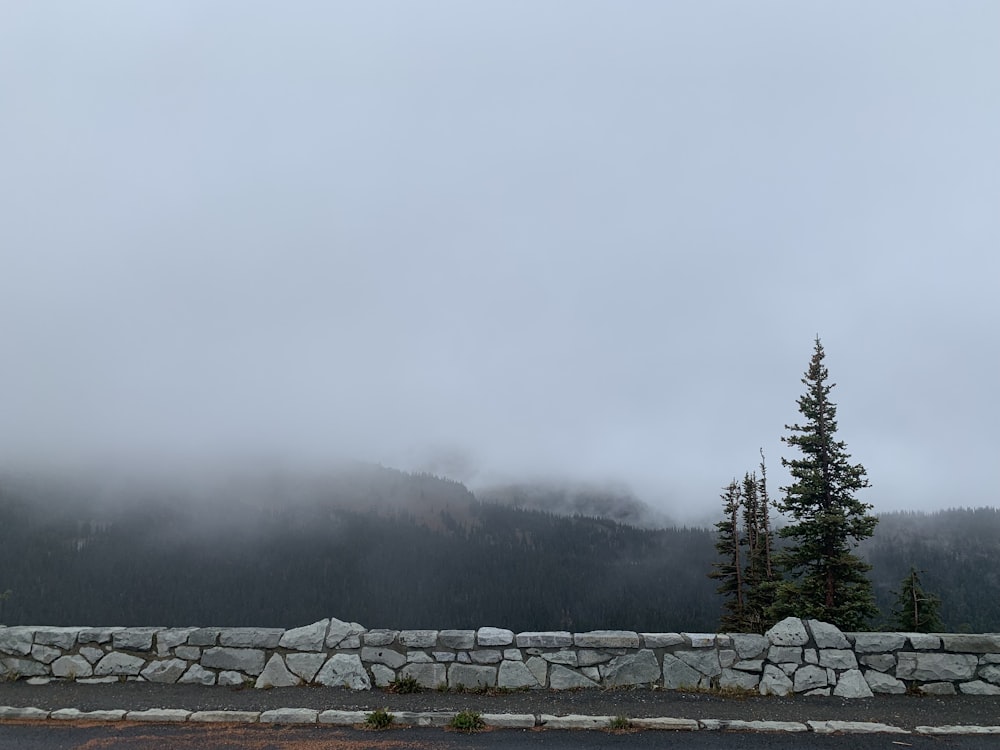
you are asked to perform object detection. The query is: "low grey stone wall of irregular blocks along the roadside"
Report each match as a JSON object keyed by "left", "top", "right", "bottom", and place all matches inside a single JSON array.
[{"left": 0, "top": 617, "right": 1000, "bottom": 698}]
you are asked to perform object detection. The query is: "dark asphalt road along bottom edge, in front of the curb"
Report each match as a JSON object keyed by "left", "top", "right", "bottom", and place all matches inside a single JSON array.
[{"left": 0, "top": 722, "right": 998, "bottom": 750}]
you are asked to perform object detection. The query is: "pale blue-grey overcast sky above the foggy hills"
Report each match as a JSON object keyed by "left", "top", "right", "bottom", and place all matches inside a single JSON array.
[{"left": 0, "top": 0, "right": 1000, "bottom": 518}]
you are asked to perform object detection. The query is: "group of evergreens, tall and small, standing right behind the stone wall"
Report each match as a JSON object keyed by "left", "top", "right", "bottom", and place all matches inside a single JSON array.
[{"left": 709, "top": 337, "right": 943, "bottom": 632}]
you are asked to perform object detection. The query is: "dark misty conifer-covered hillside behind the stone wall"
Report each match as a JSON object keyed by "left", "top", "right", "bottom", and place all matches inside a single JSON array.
[{"left": 0, "top": 467, "right": 1000, "bottom": 632}]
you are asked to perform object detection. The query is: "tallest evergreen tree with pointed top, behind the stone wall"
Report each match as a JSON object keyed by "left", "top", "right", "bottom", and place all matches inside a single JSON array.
[{"left": 772, "top": 337, "right": 878, "bottom": 630}]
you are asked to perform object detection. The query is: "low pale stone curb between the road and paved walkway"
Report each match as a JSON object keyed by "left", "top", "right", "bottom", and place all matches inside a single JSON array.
[{"left": 0, "top": 706, "right": 1000, "bottom": 736}]
